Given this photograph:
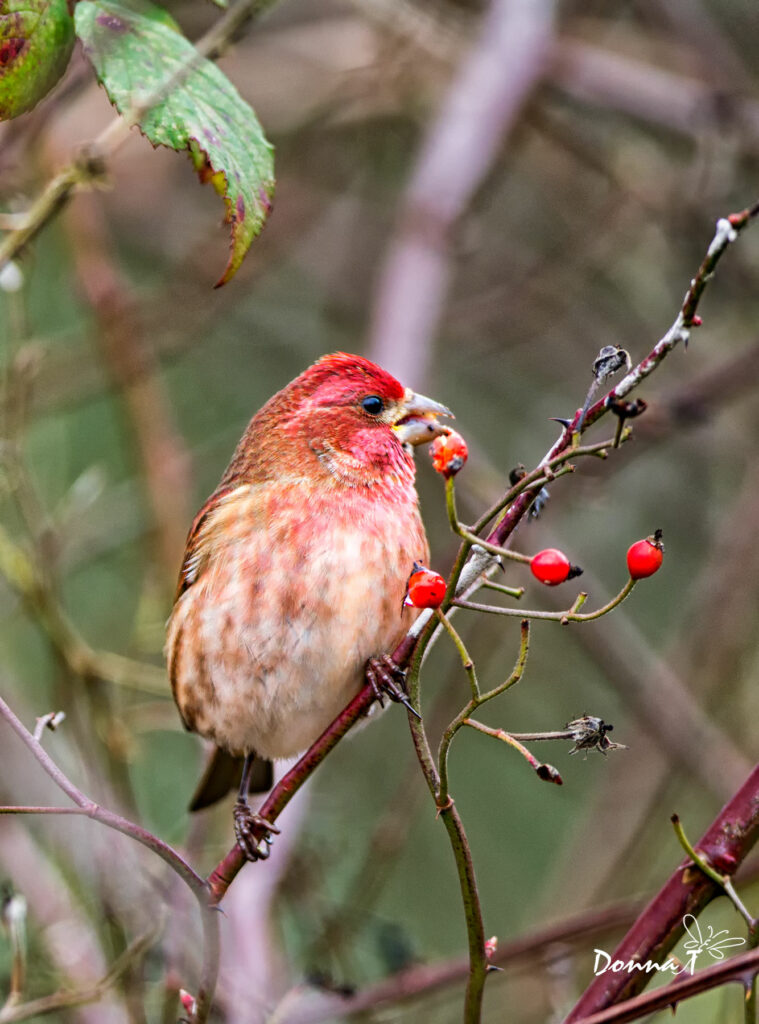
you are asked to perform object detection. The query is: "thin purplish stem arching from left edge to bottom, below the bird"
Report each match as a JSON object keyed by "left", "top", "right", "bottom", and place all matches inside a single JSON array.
[{"left": 0, "top": 697, "right": 219, "bottom": 1024}]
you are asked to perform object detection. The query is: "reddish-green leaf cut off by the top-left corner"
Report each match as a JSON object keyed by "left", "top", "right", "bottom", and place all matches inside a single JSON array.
[{"left": 0, "top": 0, "right": 75, "bottom": 121}]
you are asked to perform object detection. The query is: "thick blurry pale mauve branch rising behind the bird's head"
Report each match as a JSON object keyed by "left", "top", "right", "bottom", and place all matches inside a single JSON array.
[{"left": 369, "top": 0, "right": 554, "bottom": 381}]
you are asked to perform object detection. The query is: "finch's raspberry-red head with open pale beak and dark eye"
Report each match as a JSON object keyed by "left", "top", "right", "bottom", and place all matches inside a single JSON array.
[{"left": 224, "top": 352, "right": 452, "bottom": 486}]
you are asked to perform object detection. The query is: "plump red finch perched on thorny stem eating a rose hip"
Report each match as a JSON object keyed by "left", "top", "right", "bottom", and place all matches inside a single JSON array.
[{"left": 167, "top": 353, "right": 451, "bottom": 839}]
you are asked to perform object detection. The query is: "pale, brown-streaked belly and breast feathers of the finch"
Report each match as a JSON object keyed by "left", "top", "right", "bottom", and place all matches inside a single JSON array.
[{"left": 168, "top": 509, "right": 427, "bottom": 758}]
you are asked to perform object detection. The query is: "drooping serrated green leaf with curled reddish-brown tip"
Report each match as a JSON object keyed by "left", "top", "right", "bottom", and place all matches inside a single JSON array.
[{"left": 74, "top": 0, "right": 275, "bottom": 287}]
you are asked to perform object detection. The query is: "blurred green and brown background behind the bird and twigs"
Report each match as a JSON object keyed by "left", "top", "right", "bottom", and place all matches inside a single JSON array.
[{"left": 0, "top": 0, "right": 759, "bottom": 1024}]
